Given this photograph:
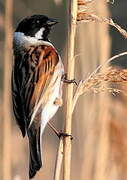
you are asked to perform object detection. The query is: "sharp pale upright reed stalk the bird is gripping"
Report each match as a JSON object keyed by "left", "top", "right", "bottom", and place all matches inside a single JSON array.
[{"left": 63, "top": 0, "right": 77, "bottom": 180}]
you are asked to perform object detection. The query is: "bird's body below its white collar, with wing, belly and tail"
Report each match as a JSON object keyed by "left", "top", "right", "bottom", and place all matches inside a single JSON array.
[{"left": 12, "top": 45, "right": 64, "bottom": 178}]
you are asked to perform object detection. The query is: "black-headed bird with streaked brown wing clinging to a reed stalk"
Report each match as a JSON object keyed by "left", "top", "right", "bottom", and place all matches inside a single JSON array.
[{"left": 12, "top": 14, "right": 64, "bottom": 179}]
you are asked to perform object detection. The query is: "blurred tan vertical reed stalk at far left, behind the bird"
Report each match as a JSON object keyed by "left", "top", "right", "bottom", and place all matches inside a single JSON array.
[{"left": 3, "top": 0, "right": 13, "bottom": 180}]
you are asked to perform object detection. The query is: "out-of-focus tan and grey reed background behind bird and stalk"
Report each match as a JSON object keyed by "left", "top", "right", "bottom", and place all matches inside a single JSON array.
[{"left": 0, "top": 0, "right": 127, "bottom": 180}]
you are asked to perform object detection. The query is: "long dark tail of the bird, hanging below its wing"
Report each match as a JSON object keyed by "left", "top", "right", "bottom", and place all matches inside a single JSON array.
[{"left": 28, "top": 125, "right": 42, "bottom": 179}]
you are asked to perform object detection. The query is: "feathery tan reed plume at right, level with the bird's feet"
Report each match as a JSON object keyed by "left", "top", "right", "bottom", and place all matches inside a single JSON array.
[{"left": 73, "top": 67, "right": 127, "bottom": 110}]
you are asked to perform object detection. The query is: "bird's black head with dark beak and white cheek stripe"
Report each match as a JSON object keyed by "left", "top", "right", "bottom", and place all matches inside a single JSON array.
[{"left": 15, "top": 15, "right": 58, "bottom": 40}]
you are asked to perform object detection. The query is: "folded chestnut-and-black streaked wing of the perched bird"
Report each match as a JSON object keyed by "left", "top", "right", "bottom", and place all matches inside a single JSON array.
[{"left": 12, "top": 45, "right": 59, "bottom": 135}]
